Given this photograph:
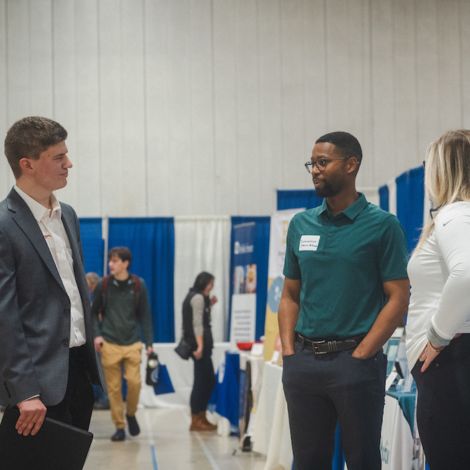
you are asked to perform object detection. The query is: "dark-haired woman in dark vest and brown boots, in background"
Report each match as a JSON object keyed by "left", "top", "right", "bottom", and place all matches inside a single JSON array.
[{"left": 183, "top": 272, "right": 217, "bottom": 431}]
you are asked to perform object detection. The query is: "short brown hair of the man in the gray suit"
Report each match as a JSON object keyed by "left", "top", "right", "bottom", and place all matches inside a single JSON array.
[{"left": 5, "top": 116, "right": 67, "bottom": 178}]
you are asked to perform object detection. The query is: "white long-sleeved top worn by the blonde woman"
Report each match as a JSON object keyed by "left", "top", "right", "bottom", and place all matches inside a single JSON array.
[{"left": 406, "top": 201, "right": 470, "bottom": 370}]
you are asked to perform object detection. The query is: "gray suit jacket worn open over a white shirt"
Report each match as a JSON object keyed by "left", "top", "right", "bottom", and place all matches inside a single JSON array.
[{"left": 0, "top": 189, "right": 99, "bottom": 406}]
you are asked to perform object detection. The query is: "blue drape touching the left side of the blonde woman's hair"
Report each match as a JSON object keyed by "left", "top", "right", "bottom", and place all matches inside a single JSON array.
[{"left": 396, "top": 167, "right": 424, "bottom": 252}]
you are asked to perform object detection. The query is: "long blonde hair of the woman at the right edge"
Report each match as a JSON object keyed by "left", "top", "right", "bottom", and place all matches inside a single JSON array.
[{"left": 418, "top": 129, "right": 470, "bottom": 248}]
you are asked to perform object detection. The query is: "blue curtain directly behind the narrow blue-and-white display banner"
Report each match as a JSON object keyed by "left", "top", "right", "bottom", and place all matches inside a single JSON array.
[{"left": 228, "top": 216, "right": 271, "bottom": 339}]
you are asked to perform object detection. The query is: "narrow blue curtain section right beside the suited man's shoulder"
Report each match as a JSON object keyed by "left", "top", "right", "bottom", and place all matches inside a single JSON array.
[{"left": 80, "top": 217, "right": 104, "bottom": 276}]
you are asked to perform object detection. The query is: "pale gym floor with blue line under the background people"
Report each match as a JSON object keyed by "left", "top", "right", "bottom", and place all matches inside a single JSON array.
[{"left": 84, "top": 408, "right": 264, "bottom": 470}]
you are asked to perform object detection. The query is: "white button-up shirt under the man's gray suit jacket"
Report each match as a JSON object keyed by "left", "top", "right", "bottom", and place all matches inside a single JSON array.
[{"left": 15, "top": 186, "right": 86, "bottom": 348}]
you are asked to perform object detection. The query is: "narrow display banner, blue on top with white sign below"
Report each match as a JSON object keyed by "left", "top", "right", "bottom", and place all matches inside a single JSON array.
[{"left": 230, "top": 222, "right": 257, "bottom": 343}]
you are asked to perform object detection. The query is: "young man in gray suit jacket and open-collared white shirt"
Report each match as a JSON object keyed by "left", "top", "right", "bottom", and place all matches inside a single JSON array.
[{"left": 0, "top": 117, "right": 99, "bottom": 436}]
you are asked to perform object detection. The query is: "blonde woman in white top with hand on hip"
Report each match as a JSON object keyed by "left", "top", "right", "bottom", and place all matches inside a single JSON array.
[{"left": 407, "top": 130, "right": 470, "bottom": 470}]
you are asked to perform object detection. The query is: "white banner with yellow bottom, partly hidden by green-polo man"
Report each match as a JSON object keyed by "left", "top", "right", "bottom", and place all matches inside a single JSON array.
[{"left": 264, "top": 209, "right": 304, "bottom": 361}]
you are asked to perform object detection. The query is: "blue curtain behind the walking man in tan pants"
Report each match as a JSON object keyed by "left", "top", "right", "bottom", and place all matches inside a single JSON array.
[{"left": 108, "top": 217, "right": 175, "bottom": 342}]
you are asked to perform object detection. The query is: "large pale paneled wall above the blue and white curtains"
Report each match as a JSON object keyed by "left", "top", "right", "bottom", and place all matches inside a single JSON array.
[{"left": 0, "top": 0, "right": 470, "bottom": 216}]
